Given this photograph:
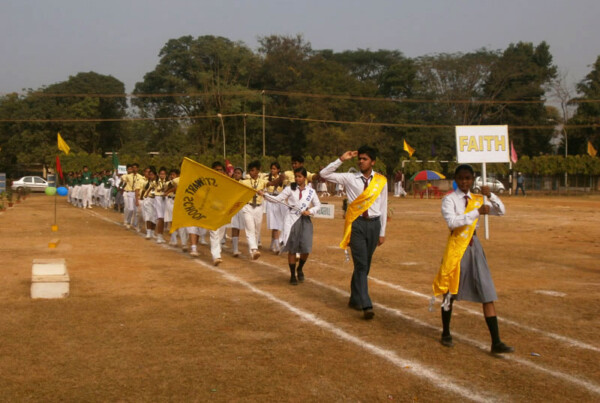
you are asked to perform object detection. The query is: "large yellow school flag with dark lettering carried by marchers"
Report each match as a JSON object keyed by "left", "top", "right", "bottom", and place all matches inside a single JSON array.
[{"left": 171, "top": 158, "right": 256, "bottom": 232}]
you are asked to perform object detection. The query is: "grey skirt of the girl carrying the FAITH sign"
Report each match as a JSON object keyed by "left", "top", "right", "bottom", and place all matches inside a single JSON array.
[{"left": 456, "top": 235, "right": 498, "bottom": 303}]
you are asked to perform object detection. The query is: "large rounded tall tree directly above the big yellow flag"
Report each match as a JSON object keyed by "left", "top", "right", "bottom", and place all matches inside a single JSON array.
[{"left": 134, "top": 35, "right": 259, "bottom": 152}]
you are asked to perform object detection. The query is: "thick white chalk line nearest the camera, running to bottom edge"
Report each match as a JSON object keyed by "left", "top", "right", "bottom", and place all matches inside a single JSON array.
[{"left": 194, "top": 260, "right": 496, "bottom": 402}]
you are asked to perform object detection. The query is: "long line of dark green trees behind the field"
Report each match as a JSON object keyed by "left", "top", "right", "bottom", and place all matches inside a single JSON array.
[{"left": 0, "top": 35, "right": 600, "bottom": 178}]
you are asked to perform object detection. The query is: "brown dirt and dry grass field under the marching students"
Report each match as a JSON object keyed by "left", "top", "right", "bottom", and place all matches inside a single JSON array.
[{"left": 0, "top": 195, "right": 600, "bottom": 402}]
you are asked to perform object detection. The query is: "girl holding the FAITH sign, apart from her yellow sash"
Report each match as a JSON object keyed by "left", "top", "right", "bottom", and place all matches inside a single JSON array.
[{"left": 434, "top": 165, "right": 514, "bottom": 354}]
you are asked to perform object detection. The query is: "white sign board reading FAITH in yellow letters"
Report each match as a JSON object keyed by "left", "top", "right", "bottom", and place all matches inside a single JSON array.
[{"left": 456, "top": 126, "right": 510, "bottom": 164}]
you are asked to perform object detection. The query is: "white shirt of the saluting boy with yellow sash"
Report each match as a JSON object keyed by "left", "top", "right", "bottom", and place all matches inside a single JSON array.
[{"left": 319, "top": 158, "right": 388, "bottom": 236}]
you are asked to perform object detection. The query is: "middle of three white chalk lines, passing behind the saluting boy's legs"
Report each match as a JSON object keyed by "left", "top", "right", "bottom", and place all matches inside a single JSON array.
[{"left": 254, "top": 261, "right": 600, "bottom": 395}]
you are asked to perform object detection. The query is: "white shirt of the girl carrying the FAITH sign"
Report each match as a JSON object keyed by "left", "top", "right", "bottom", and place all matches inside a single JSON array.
[{"left": 442, "top": 189, "right": 506, "bottom": 230}]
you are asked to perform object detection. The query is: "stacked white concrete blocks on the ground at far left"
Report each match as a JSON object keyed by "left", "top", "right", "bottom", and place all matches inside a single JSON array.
[{"left": 31, "top": 259, "right": 70, "bottom": 298}]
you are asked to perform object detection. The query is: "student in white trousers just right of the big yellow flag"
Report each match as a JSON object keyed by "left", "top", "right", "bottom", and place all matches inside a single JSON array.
[{"left": 241, "top": 161, "right": 281, "bottom": 260}]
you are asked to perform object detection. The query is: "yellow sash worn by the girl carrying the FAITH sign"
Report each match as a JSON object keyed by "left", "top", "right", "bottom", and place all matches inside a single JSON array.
[{"left": 433, "top": 194, "right": 483, "bottom": 296}]
